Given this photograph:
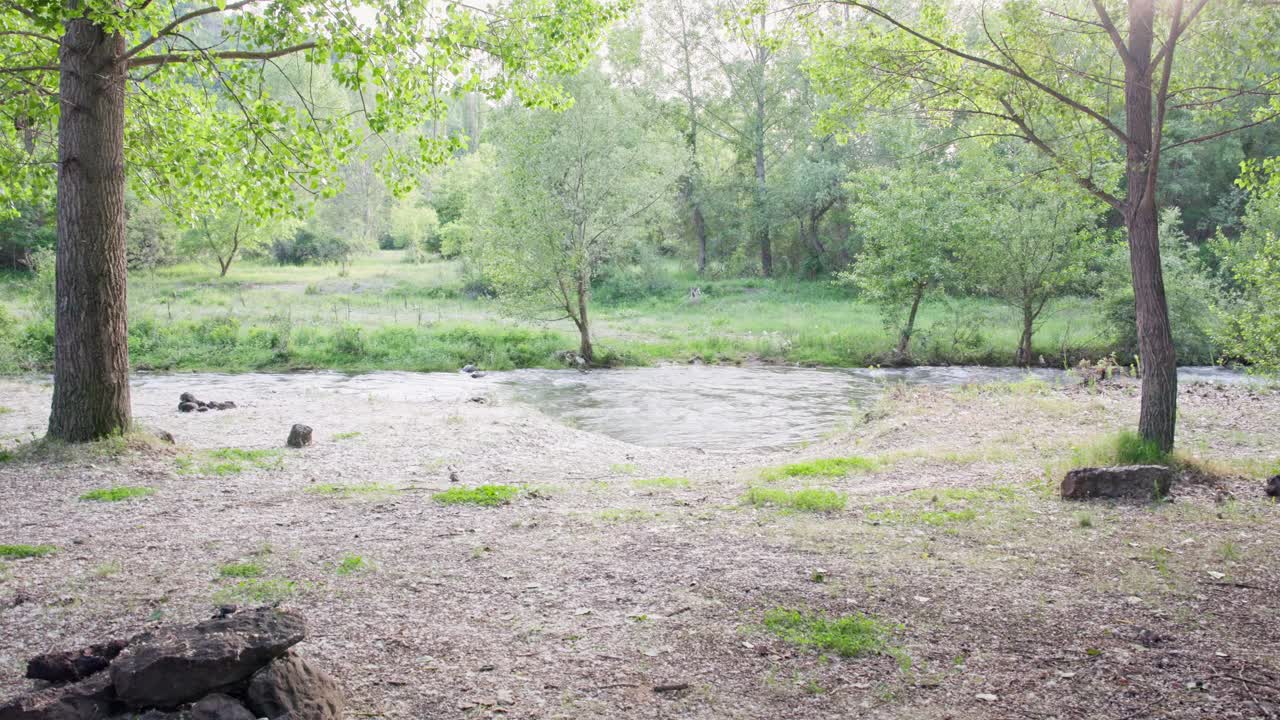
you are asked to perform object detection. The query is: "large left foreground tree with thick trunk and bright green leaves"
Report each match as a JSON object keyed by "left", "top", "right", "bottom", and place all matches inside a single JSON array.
[{"left": 0, "top": 0, "right": 620, "bottom": 441}]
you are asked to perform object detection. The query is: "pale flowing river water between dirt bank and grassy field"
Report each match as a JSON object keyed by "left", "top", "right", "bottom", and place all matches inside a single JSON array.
[{"left": 127, "top": 365, "right": 1252, "bottom": 451}]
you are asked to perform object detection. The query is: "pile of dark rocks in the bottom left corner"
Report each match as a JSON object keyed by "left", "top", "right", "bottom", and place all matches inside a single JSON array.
[{"left": 0, "top": 607, "right": 344, "bottom": 720}]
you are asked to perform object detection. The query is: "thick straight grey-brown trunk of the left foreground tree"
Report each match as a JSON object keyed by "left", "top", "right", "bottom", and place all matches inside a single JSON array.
[{"left": 49, "top": 19, "right": 132, "bottom": 442}]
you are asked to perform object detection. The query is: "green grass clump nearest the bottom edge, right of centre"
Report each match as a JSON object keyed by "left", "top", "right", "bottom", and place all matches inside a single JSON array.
[{"left": 764, "top": 607, "right": 910, "bottom": 665}]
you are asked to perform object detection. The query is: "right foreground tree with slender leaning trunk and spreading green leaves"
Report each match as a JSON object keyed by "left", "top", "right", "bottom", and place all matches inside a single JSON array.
[{"left": 812, "top": 0, "right": 1280, "bottom": 450}]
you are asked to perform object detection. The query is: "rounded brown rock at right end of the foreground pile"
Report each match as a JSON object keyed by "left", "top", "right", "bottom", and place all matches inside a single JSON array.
[{"left": 247, "top": 652, "right": 344, "bottom": 720}]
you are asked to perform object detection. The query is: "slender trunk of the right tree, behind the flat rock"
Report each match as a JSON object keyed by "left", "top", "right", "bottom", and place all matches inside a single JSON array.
[{"left": 1124, "top": 0, "right": 1178, "bottom": 451}]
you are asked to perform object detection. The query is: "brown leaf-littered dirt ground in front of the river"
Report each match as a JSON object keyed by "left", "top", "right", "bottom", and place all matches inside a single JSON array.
[{"left": 0, "top": 371, "right": 1280, "bottom": 720}]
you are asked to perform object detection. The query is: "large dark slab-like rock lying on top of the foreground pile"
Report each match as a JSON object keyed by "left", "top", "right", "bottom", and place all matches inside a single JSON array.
[{"left": 110, "top": 607, "right": 306, "bottom": 708}]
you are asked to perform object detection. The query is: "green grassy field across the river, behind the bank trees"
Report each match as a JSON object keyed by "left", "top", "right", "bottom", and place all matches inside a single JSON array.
[{"left": 0, "top": 251, "right": 1108, "bottom": 372}]
